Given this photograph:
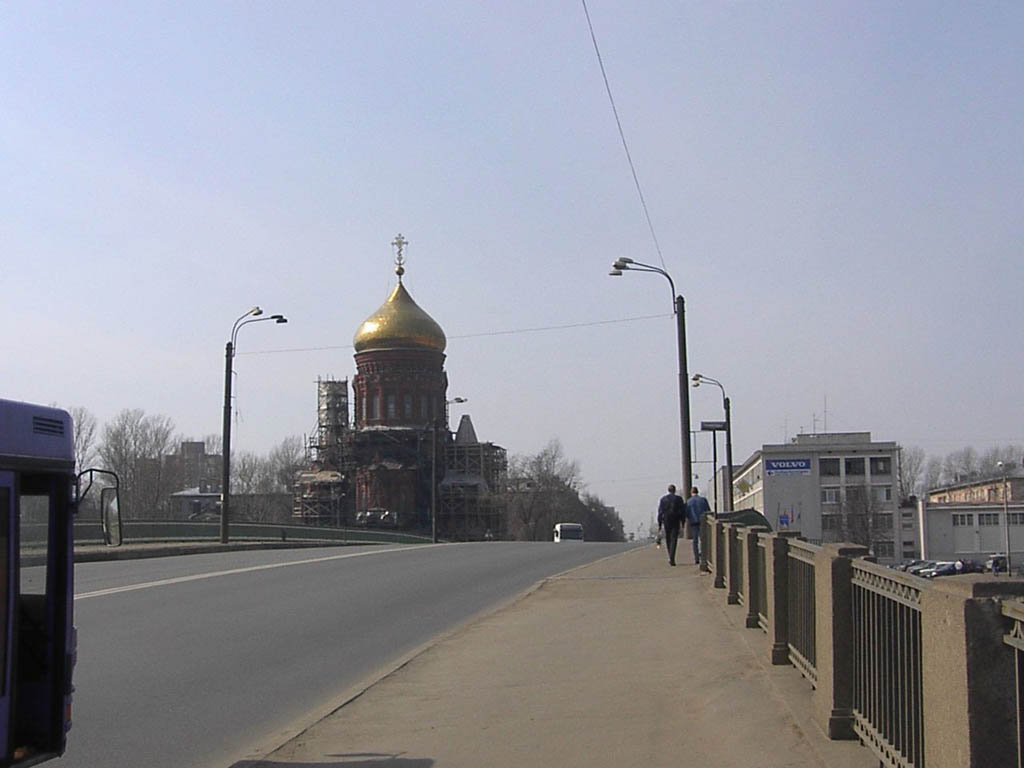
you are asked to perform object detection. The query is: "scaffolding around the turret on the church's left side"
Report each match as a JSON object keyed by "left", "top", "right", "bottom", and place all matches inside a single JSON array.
[{"left": 292, "top": 379, "right": 350, "bottom": 526}]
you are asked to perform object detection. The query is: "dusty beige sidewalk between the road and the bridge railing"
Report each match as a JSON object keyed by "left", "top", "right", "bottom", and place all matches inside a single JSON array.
[{"left": 232, "top": 547, "right": 878, "bottom": 768}]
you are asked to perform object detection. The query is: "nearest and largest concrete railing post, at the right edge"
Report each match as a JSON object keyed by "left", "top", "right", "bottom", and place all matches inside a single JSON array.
[{"left": 921, "top": 574, "right": 1024, "bottom": 768}]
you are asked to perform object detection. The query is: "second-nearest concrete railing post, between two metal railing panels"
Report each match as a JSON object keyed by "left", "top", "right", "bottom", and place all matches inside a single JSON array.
[{"left": 813, "top": 544, "right": 867, "bottom": 739}]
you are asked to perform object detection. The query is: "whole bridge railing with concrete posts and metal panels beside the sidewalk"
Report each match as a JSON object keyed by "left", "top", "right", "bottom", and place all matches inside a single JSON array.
[{"left": 702, "top": 518, "right": 1024, "bottom": 768}]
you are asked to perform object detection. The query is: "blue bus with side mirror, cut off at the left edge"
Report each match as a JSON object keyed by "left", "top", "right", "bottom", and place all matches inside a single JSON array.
[{"left": 0, "top": 399, "right": 120, "bottom": 768}]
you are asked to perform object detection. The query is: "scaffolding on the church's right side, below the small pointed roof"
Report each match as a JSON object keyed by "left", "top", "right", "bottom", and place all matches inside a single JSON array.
[{"left": 439, "top": 439, "right": 508, "bottom": 541}]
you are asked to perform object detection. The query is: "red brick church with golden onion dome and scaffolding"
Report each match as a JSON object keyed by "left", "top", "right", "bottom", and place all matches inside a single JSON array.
[{"left": 295, "top": 234, "right": 507, "bottom": 540}]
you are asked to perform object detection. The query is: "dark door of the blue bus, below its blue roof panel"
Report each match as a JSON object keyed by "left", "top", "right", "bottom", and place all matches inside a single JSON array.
[{"left": 0, "top": 471, "right": 75, "bottom": 766}]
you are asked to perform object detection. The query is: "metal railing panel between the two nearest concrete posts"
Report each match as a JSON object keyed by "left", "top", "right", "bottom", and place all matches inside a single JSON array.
[{"left": 852, "top": 560, "right": 927, "bottom": 768}]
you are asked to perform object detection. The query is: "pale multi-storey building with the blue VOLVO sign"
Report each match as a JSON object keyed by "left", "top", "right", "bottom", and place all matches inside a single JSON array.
[{"left": 733, "top": 432, "right": 916, "bottom": 562}]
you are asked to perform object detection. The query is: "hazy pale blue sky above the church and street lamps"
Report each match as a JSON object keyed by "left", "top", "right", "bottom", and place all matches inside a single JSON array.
[{"left": 0, "top": 0, "right": 1024, "bottom": 530}]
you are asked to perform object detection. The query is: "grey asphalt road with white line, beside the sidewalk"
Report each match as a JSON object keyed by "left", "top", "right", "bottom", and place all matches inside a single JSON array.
[{"left": 60, "top": 543, "right": 628, "bottom": 768}]
